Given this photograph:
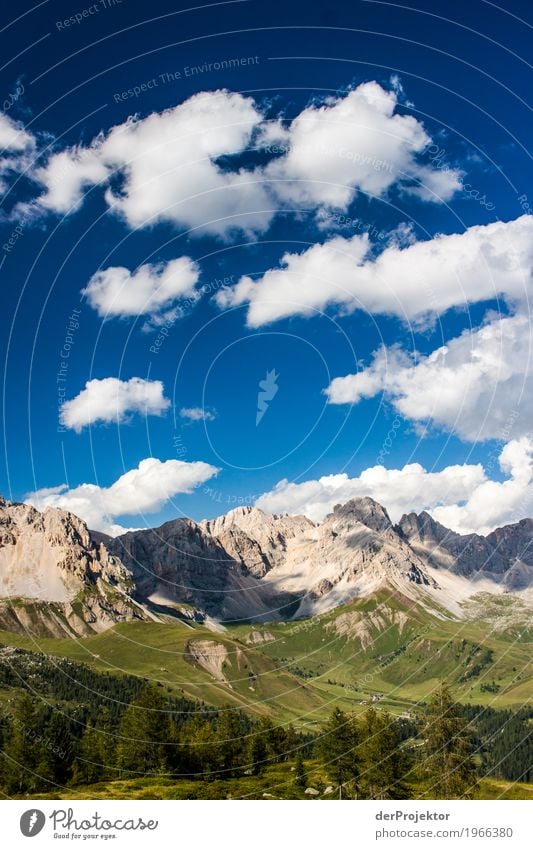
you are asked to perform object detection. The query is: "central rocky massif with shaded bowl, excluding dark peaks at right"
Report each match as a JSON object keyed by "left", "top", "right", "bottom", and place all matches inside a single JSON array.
[{"left": 106, "top": 498, "right": 436, "bottom": 621}]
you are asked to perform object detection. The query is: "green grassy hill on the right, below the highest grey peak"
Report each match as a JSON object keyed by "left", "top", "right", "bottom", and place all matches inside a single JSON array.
[{"left": 227, "top": 593, "right": 533, "bottom": 712}]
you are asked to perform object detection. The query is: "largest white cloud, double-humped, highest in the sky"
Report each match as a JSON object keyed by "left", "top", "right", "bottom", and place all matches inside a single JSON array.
[{"left": 34, "top": 82, "right": 460, "bottom": 236}]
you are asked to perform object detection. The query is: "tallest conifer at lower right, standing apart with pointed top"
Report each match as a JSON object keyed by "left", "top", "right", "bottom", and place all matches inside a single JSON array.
[{"left": 423, "top": 684, "right": 477, "bottom": 799}]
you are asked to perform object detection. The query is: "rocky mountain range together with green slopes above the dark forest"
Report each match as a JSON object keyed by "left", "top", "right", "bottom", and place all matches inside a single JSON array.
[{"left": 0, "top": 490, "right": 533, "bottom": 727}]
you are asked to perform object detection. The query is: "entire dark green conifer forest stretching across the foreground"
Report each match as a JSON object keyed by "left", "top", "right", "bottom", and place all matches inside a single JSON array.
[{"left": 0, "top": 653, "right": 532, "bottom": 799}]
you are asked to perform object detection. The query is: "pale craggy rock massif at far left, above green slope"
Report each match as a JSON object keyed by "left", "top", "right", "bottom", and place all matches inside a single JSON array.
[{"left": 0, "top": 498, "right": 144, "bottom": 636}]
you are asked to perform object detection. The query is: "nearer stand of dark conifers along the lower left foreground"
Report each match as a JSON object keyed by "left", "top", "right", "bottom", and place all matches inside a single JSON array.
[{"left": 0, "top": 685, "right": 300, "bottom": 795}]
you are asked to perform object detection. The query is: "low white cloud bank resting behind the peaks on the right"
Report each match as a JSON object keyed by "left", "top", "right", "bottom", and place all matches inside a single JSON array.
[{"left": 256, "top": 437, "right": 533, "bottom": 534}]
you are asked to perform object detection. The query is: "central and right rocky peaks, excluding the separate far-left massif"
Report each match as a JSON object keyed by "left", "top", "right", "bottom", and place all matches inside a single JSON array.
[{"left": 107, "top": 498, "right": 533, "bottom": 621}]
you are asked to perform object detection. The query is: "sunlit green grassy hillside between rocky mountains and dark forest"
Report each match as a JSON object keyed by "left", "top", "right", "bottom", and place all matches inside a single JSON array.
[{"left": 0, "top": 592, "right": 532, "bottom": 726}]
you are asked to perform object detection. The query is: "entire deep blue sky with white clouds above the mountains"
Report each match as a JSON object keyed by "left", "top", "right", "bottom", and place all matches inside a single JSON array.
[{"left": 0, "top": 0, "right": 533, "bottom": 534}]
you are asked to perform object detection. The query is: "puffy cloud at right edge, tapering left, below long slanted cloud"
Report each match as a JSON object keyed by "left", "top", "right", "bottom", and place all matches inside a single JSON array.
[{"left": 326, "top": 313, "right": 533, "bottom": 442}]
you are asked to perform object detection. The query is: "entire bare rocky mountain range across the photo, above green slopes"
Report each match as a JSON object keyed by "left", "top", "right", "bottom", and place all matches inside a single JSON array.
[{"left": 0, "top": 490, "right": 533, "bottom": 636}]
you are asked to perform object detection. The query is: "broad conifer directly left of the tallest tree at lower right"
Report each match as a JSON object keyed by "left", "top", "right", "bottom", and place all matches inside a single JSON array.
[{"left": 361, "top": 708, "right": 409, "bottom": 799}]
